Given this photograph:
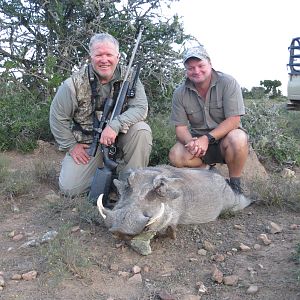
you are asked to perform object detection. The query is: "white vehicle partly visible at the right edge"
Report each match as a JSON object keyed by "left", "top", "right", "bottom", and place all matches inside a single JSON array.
[{"left": 287, "top": 37, "right": 300, "bottom": 110}]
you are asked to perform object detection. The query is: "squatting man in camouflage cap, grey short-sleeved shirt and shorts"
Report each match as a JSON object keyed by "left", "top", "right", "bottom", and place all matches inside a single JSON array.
[{"left": 169, "top": 46, "right": 248, "bottom": 193}]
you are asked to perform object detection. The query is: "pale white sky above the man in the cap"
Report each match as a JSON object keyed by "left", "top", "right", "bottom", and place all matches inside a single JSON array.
[{"left": 171, "top": 0, "right": 300, "bottom": 95}]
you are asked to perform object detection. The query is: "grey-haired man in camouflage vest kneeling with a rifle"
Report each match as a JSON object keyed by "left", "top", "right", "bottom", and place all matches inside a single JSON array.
[{"left": 50, "top": 33, "right": 152, "bottom": 196}]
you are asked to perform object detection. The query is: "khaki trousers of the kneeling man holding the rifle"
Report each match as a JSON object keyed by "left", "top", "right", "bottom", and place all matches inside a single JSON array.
[{"left": 59, "top": 122, "right": 152, "bottom": 196}]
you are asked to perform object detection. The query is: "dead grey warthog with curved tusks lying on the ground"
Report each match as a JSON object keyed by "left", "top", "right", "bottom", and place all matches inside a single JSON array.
[{"left": 98, "top": 166, "right": 251, "bottom": 236}]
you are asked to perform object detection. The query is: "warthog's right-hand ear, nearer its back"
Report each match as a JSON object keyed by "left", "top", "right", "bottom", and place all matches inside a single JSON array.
[{"left": 153, "top": 175, "right": 180, "bottom": 199}]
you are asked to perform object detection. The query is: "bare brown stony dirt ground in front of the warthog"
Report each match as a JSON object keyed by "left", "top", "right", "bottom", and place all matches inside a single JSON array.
[{"left": 0, "top": 143, "right": 300, "bottom": 300}]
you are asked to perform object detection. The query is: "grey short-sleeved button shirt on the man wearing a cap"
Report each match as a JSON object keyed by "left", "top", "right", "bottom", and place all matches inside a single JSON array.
[{"left": 170, "top": 70, "right": 245, "bottom": 136}]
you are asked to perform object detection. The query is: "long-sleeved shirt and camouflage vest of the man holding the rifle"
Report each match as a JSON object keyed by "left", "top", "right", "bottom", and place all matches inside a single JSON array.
[{"left": 49, "top": 66, "right": 148, "bottom": 150}]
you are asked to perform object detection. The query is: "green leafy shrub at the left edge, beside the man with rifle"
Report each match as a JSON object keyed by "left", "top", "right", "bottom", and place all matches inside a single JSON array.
[{"left": 0, "top": 86, "right": 51, "bottom": 152}]
